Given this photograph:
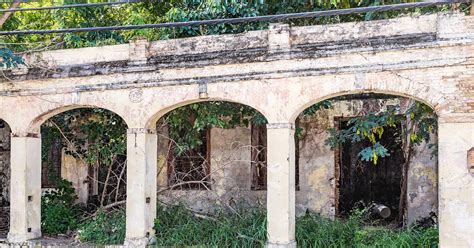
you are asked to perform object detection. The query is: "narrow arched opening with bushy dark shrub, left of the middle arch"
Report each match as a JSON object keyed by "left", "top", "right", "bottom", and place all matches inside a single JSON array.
[{"left": 41, "top": 108, "right": 127, "bottom": 241}]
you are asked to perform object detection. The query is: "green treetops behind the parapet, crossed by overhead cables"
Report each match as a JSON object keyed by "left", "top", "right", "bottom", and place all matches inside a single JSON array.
[{"left": 0, "top": 0, "right": 460, "bottom": 52}]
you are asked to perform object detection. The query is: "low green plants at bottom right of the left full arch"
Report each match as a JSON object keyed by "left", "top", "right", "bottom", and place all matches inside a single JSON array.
[{"left": 77, "top": 209, "right": 125, "bottom": 245}]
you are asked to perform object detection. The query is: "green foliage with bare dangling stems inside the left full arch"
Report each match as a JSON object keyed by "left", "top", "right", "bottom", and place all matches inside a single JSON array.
[{"left": 41, "top": 108, "right": 127, "bottom": 206}]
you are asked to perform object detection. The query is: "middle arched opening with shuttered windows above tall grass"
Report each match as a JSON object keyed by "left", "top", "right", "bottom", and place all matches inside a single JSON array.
[{"left": 155, "top": 101, "right": 267, "bottom": 247}]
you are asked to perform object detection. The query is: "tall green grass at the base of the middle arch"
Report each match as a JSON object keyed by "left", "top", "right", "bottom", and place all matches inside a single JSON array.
[{"left": 155, "top": 205, "right": 266, "bottom": 247}]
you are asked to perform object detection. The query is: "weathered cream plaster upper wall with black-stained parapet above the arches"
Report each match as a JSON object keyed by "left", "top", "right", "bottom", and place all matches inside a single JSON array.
[{"left": 0, "top": 14, "right": 474, "bottom": 132}]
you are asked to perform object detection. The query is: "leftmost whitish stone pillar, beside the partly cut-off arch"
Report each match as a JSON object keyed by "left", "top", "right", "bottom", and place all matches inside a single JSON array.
[{"left": 8, "top": 133, "right": 41, "bottom": 244}]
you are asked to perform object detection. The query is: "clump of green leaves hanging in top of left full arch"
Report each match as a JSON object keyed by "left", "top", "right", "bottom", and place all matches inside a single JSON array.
[{"left": 41, "top": 108, "right": 127, "bottom": 165}]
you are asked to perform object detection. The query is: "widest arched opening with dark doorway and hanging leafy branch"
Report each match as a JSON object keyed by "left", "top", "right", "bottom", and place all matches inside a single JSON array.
[{"left": 295, "top": 93, "right": 438, "bottom": 245}]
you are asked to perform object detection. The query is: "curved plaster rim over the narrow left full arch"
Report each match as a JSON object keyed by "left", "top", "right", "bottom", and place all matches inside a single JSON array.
[{"left": 27, "top": 104, "right": 129, "bottom": 132}]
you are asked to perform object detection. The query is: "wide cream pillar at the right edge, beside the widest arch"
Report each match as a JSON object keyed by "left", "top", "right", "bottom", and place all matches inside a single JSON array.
[{"left": 438, "top": 118, "right": 474, "bottom": 247}]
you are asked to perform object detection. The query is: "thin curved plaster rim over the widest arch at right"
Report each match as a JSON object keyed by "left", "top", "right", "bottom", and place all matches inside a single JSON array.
[{"left": 290, "top": 90, "right": 443, "bottom": 123}]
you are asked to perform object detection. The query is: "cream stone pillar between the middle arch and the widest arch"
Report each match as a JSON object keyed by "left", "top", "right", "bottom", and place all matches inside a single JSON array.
[{"left": 267, "top": 123, "right": 296, "bottom": 248}]
